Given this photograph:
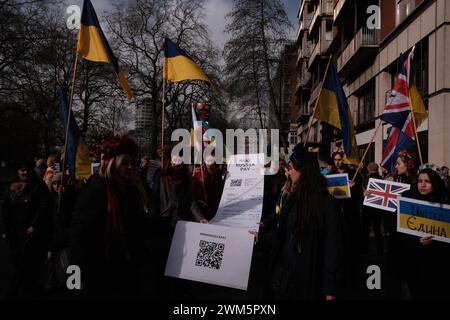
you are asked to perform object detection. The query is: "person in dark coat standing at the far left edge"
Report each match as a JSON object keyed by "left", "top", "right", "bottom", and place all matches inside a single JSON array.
[{"left": 0, "top": 164, "right": 51, "bottom": 297}]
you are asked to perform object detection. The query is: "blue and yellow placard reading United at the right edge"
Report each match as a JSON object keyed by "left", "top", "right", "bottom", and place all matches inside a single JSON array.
[{"left": 397, "top": 197, "right": 450, "bottom": 243}]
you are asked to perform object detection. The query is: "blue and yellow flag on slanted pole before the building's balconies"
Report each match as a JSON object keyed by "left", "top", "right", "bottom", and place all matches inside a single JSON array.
[{"left": 315, "top": 63, "right": 359, "bottom": 165}]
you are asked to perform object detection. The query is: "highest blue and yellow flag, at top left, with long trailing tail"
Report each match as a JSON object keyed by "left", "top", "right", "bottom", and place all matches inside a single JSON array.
[{"left": 77, "top": 0, "right": 133, "bottom": 100}]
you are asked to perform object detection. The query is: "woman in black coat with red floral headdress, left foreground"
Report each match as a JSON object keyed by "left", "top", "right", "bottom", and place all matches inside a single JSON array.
[{"left": 69, "top": 137, "right": 147, "bottom": 298}]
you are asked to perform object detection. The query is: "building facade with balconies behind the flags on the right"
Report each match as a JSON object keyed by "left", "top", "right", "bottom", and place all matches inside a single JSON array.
[{"left": 297, "top": 0, "right": 450, "bottom": 169}]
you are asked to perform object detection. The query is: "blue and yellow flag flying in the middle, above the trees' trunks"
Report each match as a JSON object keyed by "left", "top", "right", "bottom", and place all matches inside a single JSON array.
[{"left": 163, "top": 38, "right": 211, "bottom": 83}]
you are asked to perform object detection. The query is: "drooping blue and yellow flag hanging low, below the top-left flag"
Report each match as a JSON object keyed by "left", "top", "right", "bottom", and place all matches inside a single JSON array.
[{"left": 59, "top": 89, "right": 91, "bottom": 179}]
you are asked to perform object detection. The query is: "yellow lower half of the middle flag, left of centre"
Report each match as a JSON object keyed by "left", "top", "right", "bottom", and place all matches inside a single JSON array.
[{"left": 163, "top": 55, "right": 209, "bottom": 82}]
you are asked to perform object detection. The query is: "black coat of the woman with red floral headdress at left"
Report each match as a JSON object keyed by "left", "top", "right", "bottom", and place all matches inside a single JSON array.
[{"left": 69, "top": 175, "right": 147, "bottom": 296}]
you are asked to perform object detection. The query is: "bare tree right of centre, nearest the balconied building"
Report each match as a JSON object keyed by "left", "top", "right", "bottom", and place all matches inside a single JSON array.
[{"left": 224, "top": 0, "right": 291, "bottom": 140}]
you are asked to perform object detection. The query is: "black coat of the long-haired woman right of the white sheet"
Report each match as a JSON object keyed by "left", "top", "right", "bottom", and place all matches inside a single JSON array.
[{"left": 266, "top": 195, "right": 342, "bottom": 300}]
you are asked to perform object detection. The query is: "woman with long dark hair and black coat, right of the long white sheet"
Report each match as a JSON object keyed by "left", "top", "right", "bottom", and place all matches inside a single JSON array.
[{"left": 258, "top": 145, "right": 342, "bottom": 300}]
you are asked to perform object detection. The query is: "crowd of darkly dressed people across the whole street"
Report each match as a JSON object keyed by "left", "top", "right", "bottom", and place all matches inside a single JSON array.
[{"left": 0, "top": 136, "right": 450, "bottom": 300}]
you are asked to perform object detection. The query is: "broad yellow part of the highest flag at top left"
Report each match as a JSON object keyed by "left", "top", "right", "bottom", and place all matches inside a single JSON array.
[{"left": 77, "top": 24, "right": 111, "bottom": 62}]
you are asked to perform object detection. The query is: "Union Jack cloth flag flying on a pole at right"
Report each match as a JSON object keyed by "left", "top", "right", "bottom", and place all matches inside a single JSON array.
[{"left": 381, "top": 48, "right": 416, "bottom": 170}]
